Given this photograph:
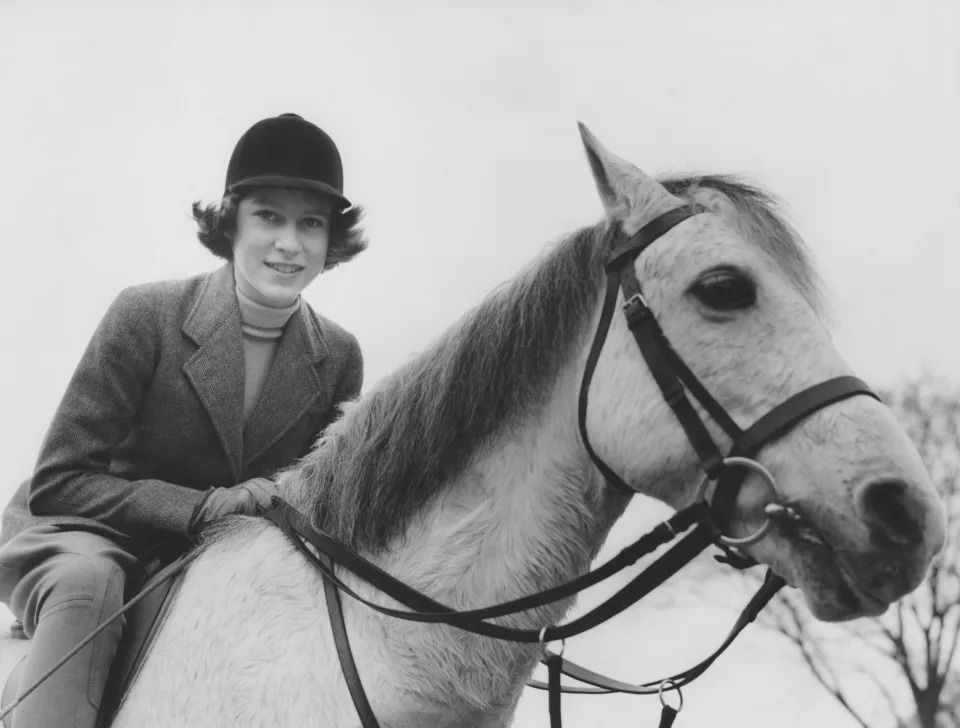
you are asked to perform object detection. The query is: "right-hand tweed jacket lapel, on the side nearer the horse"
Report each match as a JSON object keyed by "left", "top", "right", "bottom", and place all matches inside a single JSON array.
[{"left": 243, "top": 301, "right": 328, "bottom": 464}]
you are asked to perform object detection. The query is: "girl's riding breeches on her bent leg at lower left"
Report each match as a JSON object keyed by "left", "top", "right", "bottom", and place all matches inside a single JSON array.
[{"left": 0, "top": 525, "right": 136, "bottom": 728}]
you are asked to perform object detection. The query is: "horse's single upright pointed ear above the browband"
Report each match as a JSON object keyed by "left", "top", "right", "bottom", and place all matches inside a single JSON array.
[{"left": 577, "top": 122, "right": 684, "bottom": 229}]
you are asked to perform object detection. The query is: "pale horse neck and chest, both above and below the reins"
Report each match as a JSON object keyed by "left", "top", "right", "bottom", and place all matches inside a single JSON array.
[{"left": 326, "top": 367, "right": 627, "bottom": 726}]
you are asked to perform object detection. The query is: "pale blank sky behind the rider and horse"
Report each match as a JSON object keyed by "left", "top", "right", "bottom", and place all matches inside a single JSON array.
[{"left": 0, "top": 0, "right": 960, "bottom": 728}]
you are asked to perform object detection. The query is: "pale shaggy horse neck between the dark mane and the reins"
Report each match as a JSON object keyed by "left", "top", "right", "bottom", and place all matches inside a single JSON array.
[{"left": 376, "top": 371, "right": 626, "bottom": 626}]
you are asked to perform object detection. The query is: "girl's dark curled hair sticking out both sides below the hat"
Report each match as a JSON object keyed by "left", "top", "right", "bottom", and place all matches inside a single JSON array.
[{"left": 192, "top": 192, "right": 367, "bottom": 270}]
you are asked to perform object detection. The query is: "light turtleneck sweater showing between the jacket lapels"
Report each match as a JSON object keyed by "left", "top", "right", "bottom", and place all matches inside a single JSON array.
[{"left": 237, "top": 288, "right": 300, "bottom": 424}]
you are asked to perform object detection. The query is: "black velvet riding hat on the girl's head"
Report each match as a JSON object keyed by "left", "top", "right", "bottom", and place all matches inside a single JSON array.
[{"left": 225, "top": 114, "right": 350, "bottom": 208}]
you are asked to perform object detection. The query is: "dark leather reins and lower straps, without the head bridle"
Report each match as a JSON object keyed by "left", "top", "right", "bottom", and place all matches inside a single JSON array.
[{"left": 264, "top": 501, "right": 785, "bottom": 728}]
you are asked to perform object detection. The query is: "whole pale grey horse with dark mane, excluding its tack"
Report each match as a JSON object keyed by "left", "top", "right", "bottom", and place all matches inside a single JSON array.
[{"left": 1, "top": 130, "right": 943, "bottom": 728}]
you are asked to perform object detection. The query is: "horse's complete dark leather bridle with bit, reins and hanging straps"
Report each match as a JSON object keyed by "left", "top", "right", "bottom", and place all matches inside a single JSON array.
[{"left": 265, "top": 207, "right": 879, "bottom": 728}]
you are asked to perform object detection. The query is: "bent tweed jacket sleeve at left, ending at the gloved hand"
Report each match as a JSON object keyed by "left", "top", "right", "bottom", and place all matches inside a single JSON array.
[{"left": 29, "top": 289, "right": 204, "bottom": 539}]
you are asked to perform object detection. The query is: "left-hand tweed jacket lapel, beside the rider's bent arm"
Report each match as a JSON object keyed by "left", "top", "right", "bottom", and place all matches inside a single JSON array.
[{"left": 183, "top": 265, "right": 245, "bottom": 482}]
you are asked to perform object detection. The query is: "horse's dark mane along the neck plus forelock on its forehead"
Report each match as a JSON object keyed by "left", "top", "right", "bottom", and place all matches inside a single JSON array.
[{"left": 283, "top": 176, "right": 817, "bottom": 551}]
